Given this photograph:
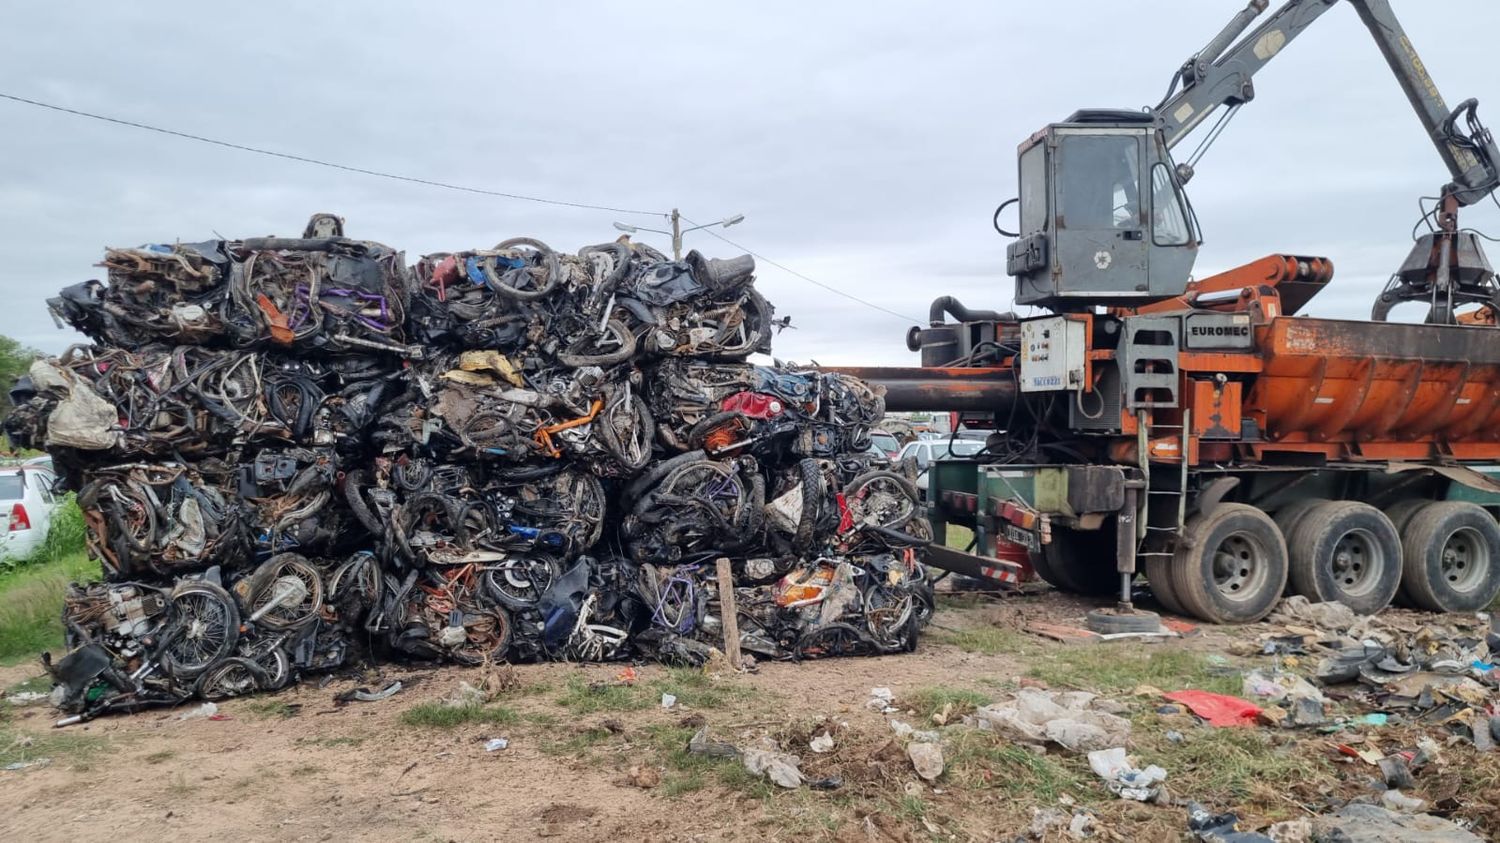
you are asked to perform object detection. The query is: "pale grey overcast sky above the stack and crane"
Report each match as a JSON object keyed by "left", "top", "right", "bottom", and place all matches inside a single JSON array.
[{"left": 0, "top": 0, "right": 1500, "bottom": 365}]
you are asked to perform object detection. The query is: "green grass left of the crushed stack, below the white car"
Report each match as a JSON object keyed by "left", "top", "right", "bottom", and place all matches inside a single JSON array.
[{"left": 0, "top": 552, "right": 99, "bottom": 665}]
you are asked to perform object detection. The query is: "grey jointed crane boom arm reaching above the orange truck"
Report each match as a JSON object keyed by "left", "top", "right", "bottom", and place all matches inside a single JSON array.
[{"left": 1155, "top": 0, "right": 1500, "bottom": 206}]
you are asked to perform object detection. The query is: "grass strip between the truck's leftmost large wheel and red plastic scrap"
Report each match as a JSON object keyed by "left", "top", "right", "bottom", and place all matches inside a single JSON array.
[{"left": 1028, "top": 644, "right": 1242, "bottom": 696}]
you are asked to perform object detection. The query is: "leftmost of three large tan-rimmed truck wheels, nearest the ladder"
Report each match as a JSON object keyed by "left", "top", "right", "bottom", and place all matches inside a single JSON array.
[{"left": 1172, "top": 504, "right": 1287, "bottom": 624}]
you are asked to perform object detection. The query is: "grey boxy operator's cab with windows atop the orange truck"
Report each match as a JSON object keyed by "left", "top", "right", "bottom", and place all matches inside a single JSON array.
[{"left": 1007, "top": 110, "right": 1202, "bottom": 312}]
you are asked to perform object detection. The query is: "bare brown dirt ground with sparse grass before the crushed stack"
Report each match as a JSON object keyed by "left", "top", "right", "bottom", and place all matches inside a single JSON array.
[{"left": 0, "top": 594, "right": 1500, "bottom": 840}]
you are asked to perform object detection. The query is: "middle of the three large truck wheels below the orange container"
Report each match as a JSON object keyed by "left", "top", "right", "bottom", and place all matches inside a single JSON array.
[{"left": 1287, "top": 501, "right": 1401, "bottom": 615}]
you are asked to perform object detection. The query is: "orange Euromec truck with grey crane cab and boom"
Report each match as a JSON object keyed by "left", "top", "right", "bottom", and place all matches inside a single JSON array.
[{"left": 843, "top": 0, "right": 1500, "bottom": 632}]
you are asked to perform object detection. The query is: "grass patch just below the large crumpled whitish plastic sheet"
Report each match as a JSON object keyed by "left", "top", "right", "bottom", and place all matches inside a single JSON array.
[{"left": 944, "top": 729, "right": 1092, "bottom": 804}]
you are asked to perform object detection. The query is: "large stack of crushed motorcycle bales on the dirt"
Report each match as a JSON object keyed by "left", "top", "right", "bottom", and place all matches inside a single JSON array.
[{"left": 6, "top": 215, "right": 932, "bottom": 719}]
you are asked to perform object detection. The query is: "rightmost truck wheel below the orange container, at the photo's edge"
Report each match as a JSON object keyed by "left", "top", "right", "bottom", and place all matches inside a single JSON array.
[{"left": 1401, "top": 501, "right": 1500, "bottom": 612}]
